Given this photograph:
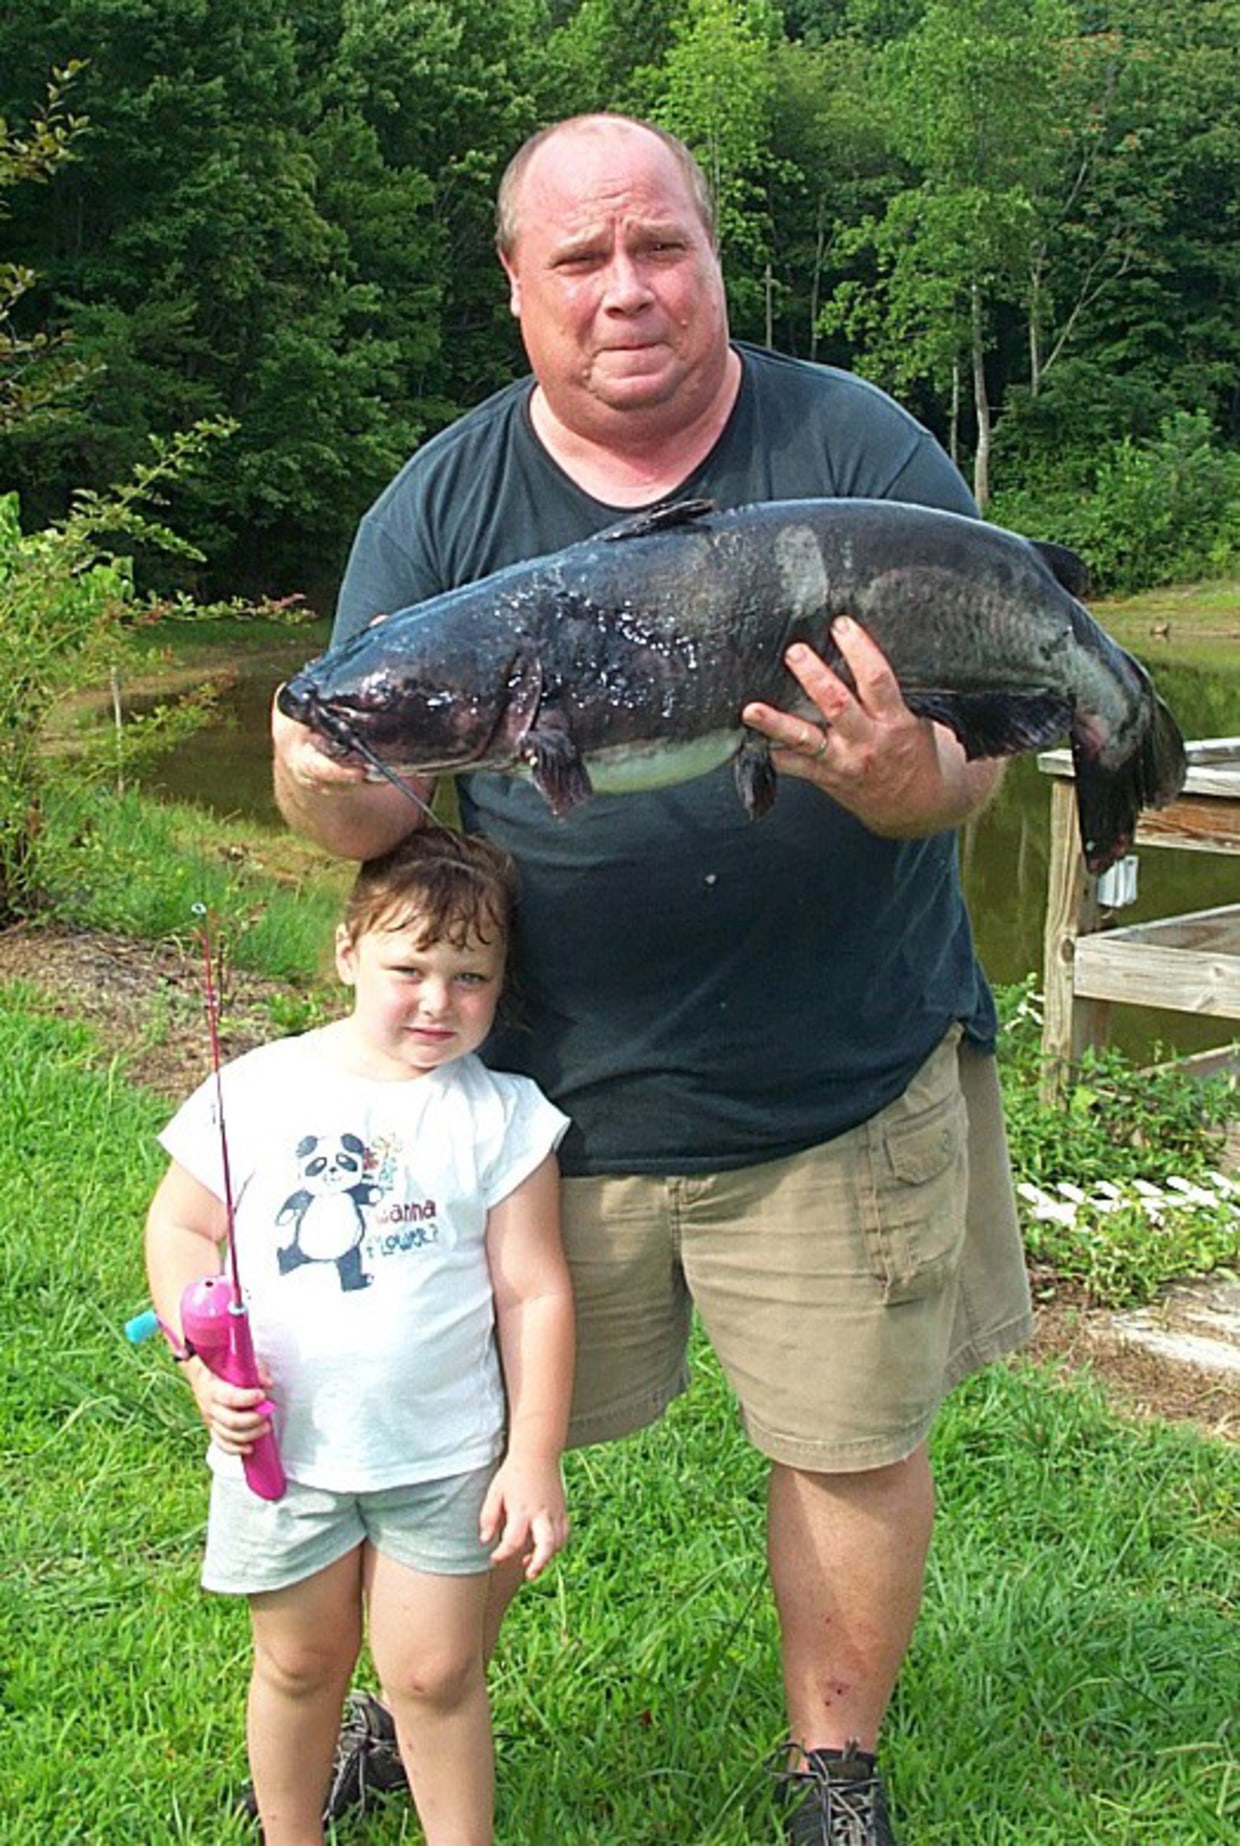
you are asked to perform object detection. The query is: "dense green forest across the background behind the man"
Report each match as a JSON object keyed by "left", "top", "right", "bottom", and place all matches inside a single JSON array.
[{"left": 0, "top": 0, "right": 1240, "bottom": 609}]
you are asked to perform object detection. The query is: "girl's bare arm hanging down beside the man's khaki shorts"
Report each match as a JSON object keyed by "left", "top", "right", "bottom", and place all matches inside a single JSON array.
[{"left": 482, "top": 1154, "right": 574, "bottom": 1578}]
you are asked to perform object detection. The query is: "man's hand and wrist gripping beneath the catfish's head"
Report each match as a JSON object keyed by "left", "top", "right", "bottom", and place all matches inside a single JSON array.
[{"left": 271, "top": 705, "right": 434, "bottom": 858}]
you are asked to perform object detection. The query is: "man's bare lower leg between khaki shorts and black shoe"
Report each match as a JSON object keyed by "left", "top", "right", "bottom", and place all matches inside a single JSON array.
[{"left": 768, "top": 1444, "right": 934, "bottom": 1752}]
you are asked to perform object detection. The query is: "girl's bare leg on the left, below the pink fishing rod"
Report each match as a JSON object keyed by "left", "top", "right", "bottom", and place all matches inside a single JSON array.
[{"left": 247, "top": 1545, "right": 362, "bottom": 1846}]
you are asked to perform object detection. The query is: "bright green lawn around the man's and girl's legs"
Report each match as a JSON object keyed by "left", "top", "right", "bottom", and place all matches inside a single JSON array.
[{"left": 0, "top": 989, "right": 1240, "bottom": 1846}]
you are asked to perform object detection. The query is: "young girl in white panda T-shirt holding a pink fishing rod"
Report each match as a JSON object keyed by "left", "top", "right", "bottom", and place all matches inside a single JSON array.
[{"left": 146, "top": 829, "right": 572, "bottom": 1846}]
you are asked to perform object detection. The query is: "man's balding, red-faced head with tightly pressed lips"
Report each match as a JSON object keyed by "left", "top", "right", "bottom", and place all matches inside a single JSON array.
[{"left": 504, "top": 124, "right": 729, "bottom": 441}]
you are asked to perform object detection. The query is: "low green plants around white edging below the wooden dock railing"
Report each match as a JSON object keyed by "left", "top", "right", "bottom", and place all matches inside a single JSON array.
[{"left": 998, "top": 982, "right": 1240, "bottom": 1307}]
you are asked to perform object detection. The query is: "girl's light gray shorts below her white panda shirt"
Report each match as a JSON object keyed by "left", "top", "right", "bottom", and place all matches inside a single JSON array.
[{"left": 203, "top": 1462, "right": 498, "bottom": 1597}]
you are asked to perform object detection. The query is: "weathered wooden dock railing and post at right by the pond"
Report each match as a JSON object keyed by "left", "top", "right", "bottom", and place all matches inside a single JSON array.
[{"left": 1037, "top": 737, "right": 1240, "bottom": 1102}]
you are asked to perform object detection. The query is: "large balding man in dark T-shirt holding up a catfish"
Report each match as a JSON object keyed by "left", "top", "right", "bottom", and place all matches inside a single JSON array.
[{"left": 275, "top": 116, "right": 1030, "bottom": 1846}]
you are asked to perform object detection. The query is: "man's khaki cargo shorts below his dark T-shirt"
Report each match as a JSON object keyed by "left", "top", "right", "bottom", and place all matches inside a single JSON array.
[{"left": 563, "top": 1028, "right": 1031, "bottom": 1473}]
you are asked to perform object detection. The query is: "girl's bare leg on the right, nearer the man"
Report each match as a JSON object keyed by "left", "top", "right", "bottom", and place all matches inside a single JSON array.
[{"left": 364, "top": 1545, "right": 495, "bottom": 1846}]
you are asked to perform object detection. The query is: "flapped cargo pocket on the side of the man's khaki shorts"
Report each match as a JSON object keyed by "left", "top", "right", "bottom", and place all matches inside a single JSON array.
[{"left": 871, "top": 1043, "right": 969, "bottom": 1307}]
